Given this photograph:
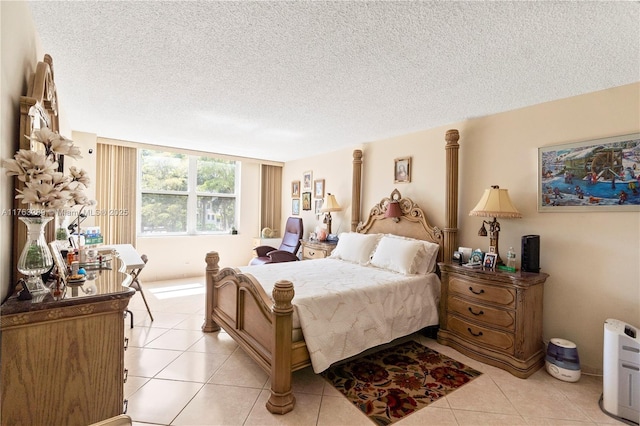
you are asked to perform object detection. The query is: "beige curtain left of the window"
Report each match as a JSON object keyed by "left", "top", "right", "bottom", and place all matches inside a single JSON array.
[{"left": 96, "top": 143, "right": 137, "bottom": 247}]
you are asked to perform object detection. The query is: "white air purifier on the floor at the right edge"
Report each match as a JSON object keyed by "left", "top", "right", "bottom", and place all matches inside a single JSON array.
[{"left": 601, "top": 319, "right": 640, "bottom": 424}]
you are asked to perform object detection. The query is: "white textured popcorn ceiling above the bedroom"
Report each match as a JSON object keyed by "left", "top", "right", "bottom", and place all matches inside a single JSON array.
[{"left": 30, "top": 1, "right": 640, "bottom": 161}]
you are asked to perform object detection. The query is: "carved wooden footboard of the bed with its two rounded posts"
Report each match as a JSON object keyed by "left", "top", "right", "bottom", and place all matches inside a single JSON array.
[{"left": 202, "top": 251, "right": 311, "bottom": 414}]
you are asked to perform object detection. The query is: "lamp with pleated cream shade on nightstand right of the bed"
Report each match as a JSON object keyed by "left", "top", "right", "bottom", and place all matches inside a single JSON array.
[{"left": 469, "top": 185, "right": 522, "bottom": 265}]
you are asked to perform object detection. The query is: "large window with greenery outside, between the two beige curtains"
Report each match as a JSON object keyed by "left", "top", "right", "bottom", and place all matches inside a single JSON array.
[{"left": 138, "top": 149, "right": 240, "bottom": 235}]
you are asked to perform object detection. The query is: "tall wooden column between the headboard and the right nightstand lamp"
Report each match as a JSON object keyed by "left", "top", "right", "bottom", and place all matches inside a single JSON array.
[{"left": 443, "top": 129, "right": 460, "bottom": 262}]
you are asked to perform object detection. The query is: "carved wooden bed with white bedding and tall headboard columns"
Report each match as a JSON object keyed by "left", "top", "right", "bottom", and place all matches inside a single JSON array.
[{"left": 202, "top": 130, "right": 459, "bottom": 414}]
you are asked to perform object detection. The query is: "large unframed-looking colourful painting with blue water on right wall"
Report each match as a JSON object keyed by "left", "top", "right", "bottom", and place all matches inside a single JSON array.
[{"left": 538, "top": 133, "right": 640, "bottom": 212}]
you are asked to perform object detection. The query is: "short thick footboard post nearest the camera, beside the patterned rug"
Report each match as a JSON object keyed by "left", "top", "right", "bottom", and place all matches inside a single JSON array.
[{"left": 267, "top": 280, "right": 296, "bottom": 414}]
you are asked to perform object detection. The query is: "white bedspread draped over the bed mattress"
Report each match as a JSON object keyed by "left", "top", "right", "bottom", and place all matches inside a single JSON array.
[{"left": 238, "top": 259, "right": 440, "bottom": 373}]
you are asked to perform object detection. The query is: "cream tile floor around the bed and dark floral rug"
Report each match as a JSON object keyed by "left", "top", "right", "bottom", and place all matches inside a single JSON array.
[{"left": 125, "top": 278, "right": 622, "bottom": 426}]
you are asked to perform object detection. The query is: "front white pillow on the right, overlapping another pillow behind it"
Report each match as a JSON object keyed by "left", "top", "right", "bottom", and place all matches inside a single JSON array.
[{"left": 371, "top": 235, "right": 424, "bottom": 275}]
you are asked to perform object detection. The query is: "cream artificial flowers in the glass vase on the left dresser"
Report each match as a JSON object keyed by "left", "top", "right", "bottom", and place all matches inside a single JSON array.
[{"left": 2, "top": 127, "right": 91, "bottom": 214}]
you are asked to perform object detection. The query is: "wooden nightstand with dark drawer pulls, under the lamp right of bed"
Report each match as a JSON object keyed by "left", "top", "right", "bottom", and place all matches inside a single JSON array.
[{"left": 438, "top": 263, "right": 548, "bottom": 378}]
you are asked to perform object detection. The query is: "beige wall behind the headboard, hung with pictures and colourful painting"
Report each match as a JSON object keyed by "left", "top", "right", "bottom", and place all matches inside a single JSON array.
[{"left": 283, "top": 83, "right": 640, "bottom": 371}]
